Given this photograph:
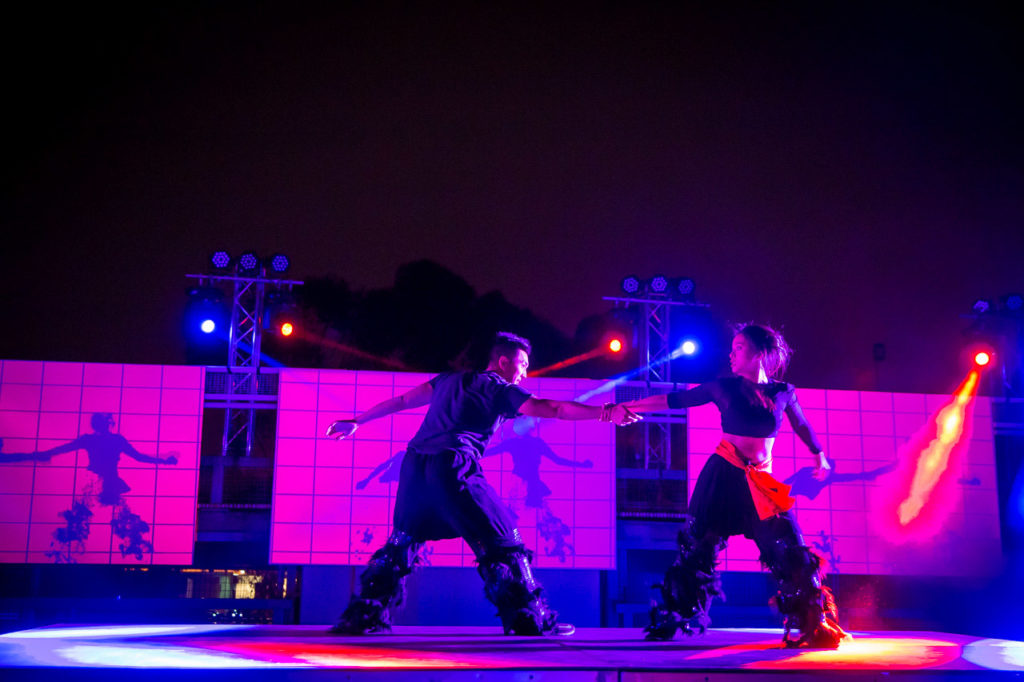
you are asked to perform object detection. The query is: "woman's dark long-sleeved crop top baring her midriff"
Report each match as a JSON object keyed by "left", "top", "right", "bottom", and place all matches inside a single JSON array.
[{"left": 666, "top": 377, "right": 822, "bottom": 455}]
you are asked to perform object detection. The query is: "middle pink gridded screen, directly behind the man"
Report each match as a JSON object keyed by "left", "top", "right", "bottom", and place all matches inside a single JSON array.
[{"left": 270, "top": 370, "right": 615, "bottom": 568}]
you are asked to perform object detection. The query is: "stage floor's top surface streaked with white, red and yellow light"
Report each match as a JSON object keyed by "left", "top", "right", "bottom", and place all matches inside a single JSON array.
[{"left": 0, "top": 625, "right": 1024, "bottom": 672}]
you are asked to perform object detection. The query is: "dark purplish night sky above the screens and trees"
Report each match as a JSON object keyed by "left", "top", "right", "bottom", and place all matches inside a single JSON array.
[{"left": 0, "top": 3, "right": 1024, "bottom": 391}]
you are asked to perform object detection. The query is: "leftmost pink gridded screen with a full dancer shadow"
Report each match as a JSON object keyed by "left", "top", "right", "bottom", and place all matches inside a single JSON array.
[{"left": 0, "top": 360, "right": 204, "bottom": 564}]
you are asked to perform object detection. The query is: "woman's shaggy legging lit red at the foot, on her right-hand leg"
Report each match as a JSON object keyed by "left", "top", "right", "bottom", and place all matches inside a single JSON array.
[{"left": 758, "top": 520, "right": 849, "bottom": 649}]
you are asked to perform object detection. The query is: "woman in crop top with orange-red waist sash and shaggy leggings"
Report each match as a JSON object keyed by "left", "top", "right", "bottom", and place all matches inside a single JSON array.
[{"left": 624, "top": 325, "right": 849, "bottom": 648}]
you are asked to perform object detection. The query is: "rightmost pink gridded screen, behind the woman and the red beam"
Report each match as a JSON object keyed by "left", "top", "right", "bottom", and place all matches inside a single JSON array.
[{"left": 687, "top": 389, "right": 1000, "bottom": 576}]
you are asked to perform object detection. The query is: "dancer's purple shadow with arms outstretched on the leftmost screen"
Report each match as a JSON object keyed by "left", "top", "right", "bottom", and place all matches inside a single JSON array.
[{"left": 36, "top": 412, "right": 178, "bottom": 563}]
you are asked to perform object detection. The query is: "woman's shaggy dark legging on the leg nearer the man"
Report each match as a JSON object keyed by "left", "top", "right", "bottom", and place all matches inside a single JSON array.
[{"left": 644, "top": 516, "right": 725, "bottom": 640}]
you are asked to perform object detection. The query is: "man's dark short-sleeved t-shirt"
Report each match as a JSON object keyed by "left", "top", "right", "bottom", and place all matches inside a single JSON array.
[{"left": 409, "top": 372, "right": 529, "bottom": 458}]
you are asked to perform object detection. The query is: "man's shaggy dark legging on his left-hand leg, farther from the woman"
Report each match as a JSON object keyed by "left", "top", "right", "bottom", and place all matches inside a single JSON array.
[{"left": 329, "top": 530, "right": 423, "bottom": 635}]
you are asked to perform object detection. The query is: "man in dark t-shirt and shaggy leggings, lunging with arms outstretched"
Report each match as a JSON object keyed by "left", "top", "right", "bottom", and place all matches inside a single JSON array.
[{"left": 327, "top": 332, "right": 640, "bottom": 635}]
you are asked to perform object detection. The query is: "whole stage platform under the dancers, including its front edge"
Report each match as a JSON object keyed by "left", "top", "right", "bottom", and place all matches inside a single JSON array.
[{"left": 0, "top": 625, "right": 1024, "bottom": 682}]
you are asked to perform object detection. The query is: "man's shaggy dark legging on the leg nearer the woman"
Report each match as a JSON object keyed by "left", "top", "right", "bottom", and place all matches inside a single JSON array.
[{"left": 471, "top": 534, "right": 569, "bottom": 635}]
